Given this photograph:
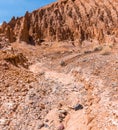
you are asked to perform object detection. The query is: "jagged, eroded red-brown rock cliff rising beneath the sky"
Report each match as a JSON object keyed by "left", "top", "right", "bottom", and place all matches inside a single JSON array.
[{"left": 0, "top": 0, "right": 118, "bottom": 44}]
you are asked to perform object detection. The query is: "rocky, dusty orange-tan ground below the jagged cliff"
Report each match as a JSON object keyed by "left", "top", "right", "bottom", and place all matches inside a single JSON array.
[{"left": 0, "top": 42, "right": 118, "bottom": 130}]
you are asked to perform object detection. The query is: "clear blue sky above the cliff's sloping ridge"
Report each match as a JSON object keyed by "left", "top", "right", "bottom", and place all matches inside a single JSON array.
[{"left": 0, "top": 0, "right": 56, "bottom": 23}]
